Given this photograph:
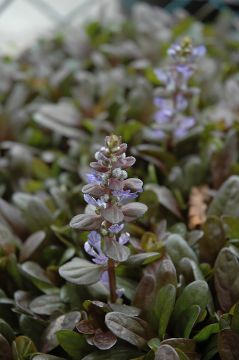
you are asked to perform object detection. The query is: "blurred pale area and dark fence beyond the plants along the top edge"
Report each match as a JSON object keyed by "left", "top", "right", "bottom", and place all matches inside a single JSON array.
[{"left": 0, "top": 0, "right": 239, "bottom": 54}]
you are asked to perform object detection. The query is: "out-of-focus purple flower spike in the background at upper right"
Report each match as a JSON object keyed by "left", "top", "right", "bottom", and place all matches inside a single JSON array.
[{"left": 149, "top": 38, "right": 206, "bottom": 140}]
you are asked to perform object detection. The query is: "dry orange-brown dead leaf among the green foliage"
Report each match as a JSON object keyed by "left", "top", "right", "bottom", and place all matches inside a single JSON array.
[{"left": 188, "top": 185, "right": 210, "bottom": 229}]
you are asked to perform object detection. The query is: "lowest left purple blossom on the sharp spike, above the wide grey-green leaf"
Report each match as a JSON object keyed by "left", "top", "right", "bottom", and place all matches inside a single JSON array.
[{"left": 84, "top": 231, "right": 108, "bottom": 265}]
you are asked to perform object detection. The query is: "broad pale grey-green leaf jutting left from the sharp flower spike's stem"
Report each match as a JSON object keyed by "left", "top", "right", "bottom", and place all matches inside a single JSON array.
[{"left": 59, "top": 258, "right": 104, "bottom": 285}]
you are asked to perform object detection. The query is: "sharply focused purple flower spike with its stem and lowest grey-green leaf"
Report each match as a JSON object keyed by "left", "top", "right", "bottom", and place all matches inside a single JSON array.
[{"left": 60, "top": 135, "right": 147, "bottom": 303}]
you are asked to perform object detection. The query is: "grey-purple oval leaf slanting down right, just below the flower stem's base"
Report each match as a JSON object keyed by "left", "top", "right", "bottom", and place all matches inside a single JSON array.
[{"left": 105, "top": 312, "right": 147, "bottom": 348}]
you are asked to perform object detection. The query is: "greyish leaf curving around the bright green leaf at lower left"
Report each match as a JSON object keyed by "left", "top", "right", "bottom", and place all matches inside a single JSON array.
[{"left": 42, "top": 311, "right": 81, "bottom": 352}]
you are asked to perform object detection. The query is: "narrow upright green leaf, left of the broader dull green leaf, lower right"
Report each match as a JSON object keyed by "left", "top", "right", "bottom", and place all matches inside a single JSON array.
[{"left": 154, "top": 284, "right": 176, "bottom": 339}]
